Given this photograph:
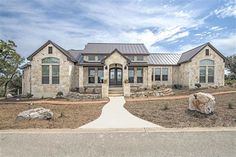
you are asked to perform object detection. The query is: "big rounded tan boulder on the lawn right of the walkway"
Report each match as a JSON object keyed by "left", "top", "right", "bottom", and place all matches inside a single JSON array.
[{"left": 189, "top": 92, "right": 216, "bottom": 114}]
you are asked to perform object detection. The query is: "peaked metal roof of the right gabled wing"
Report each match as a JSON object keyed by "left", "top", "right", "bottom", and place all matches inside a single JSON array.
[{"left": 178, "top": 42, "right": 226, "bottom": 64}]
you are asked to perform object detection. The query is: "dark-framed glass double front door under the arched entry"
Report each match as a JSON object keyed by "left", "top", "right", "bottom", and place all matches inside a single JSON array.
[{"left": 109, "top": 68, "right": 122, "bottom": 86}]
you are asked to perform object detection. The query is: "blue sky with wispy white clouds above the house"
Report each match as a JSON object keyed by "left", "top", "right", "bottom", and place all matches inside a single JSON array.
[{"left": 0, "top": 0, "right": 236, "bottom": 57}]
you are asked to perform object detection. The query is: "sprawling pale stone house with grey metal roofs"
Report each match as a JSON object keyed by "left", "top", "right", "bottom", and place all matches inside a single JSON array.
[{"left": 22, "top": 40, "right": 225, "bottom": 97}]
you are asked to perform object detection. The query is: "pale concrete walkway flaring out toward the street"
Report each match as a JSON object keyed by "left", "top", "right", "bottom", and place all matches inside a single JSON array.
[{"left": 80, "top": 96, "right": 160, "bottom": 128}]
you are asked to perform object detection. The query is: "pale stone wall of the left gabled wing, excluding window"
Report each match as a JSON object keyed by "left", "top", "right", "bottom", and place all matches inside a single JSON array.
[{"left": 27, "top": 44, "right": 74, "bottom": 97}]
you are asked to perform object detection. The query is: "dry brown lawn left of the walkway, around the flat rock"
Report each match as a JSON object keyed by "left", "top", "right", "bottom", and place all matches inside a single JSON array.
[{"left": 0, "top": 103, "right": 105, "bottom": 129}]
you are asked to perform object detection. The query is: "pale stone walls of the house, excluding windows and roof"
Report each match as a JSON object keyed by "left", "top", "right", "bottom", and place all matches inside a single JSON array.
[{"left": 22, "top": 44, "right": 225, "bottom": 97}]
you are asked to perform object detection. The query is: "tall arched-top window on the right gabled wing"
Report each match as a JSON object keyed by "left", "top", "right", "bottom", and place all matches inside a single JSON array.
[{"left": 199, "top": 59, "right": 215, "bottom": 83}]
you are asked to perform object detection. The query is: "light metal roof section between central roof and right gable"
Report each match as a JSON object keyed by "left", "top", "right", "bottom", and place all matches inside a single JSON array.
[{"left": 148, "top": 53, "right": 181, "bottom": 65}]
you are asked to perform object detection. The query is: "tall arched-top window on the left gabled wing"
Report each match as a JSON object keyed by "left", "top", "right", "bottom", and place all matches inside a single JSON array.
[{"left": 42, "top": 57, "right": 60, "bottom": 84}]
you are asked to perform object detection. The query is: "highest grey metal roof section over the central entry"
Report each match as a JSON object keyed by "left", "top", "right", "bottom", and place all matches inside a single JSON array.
[{"left": 83, "top": 43, "right": 149, "bottom": 54}]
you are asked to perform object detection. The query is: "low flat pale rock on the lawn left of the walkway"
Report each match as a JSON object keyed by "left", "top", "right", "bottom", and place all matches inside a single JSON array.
[{"left": 16, "top": 107, "right": 53, "bottom": 120}]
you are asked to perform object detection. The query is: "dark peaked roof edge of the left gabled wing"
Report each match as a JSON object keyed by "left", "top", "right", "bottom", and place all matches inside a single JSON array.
[{"left": 27, "top": 40, "right": 77, "bottom": 62}]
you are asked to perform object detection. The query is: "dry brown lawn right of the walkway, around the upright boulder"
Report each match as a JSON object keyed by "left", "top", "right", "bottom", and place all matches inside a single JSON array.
[{"left": 125, "top": 94, "right": 236, "bottom": 128}]
